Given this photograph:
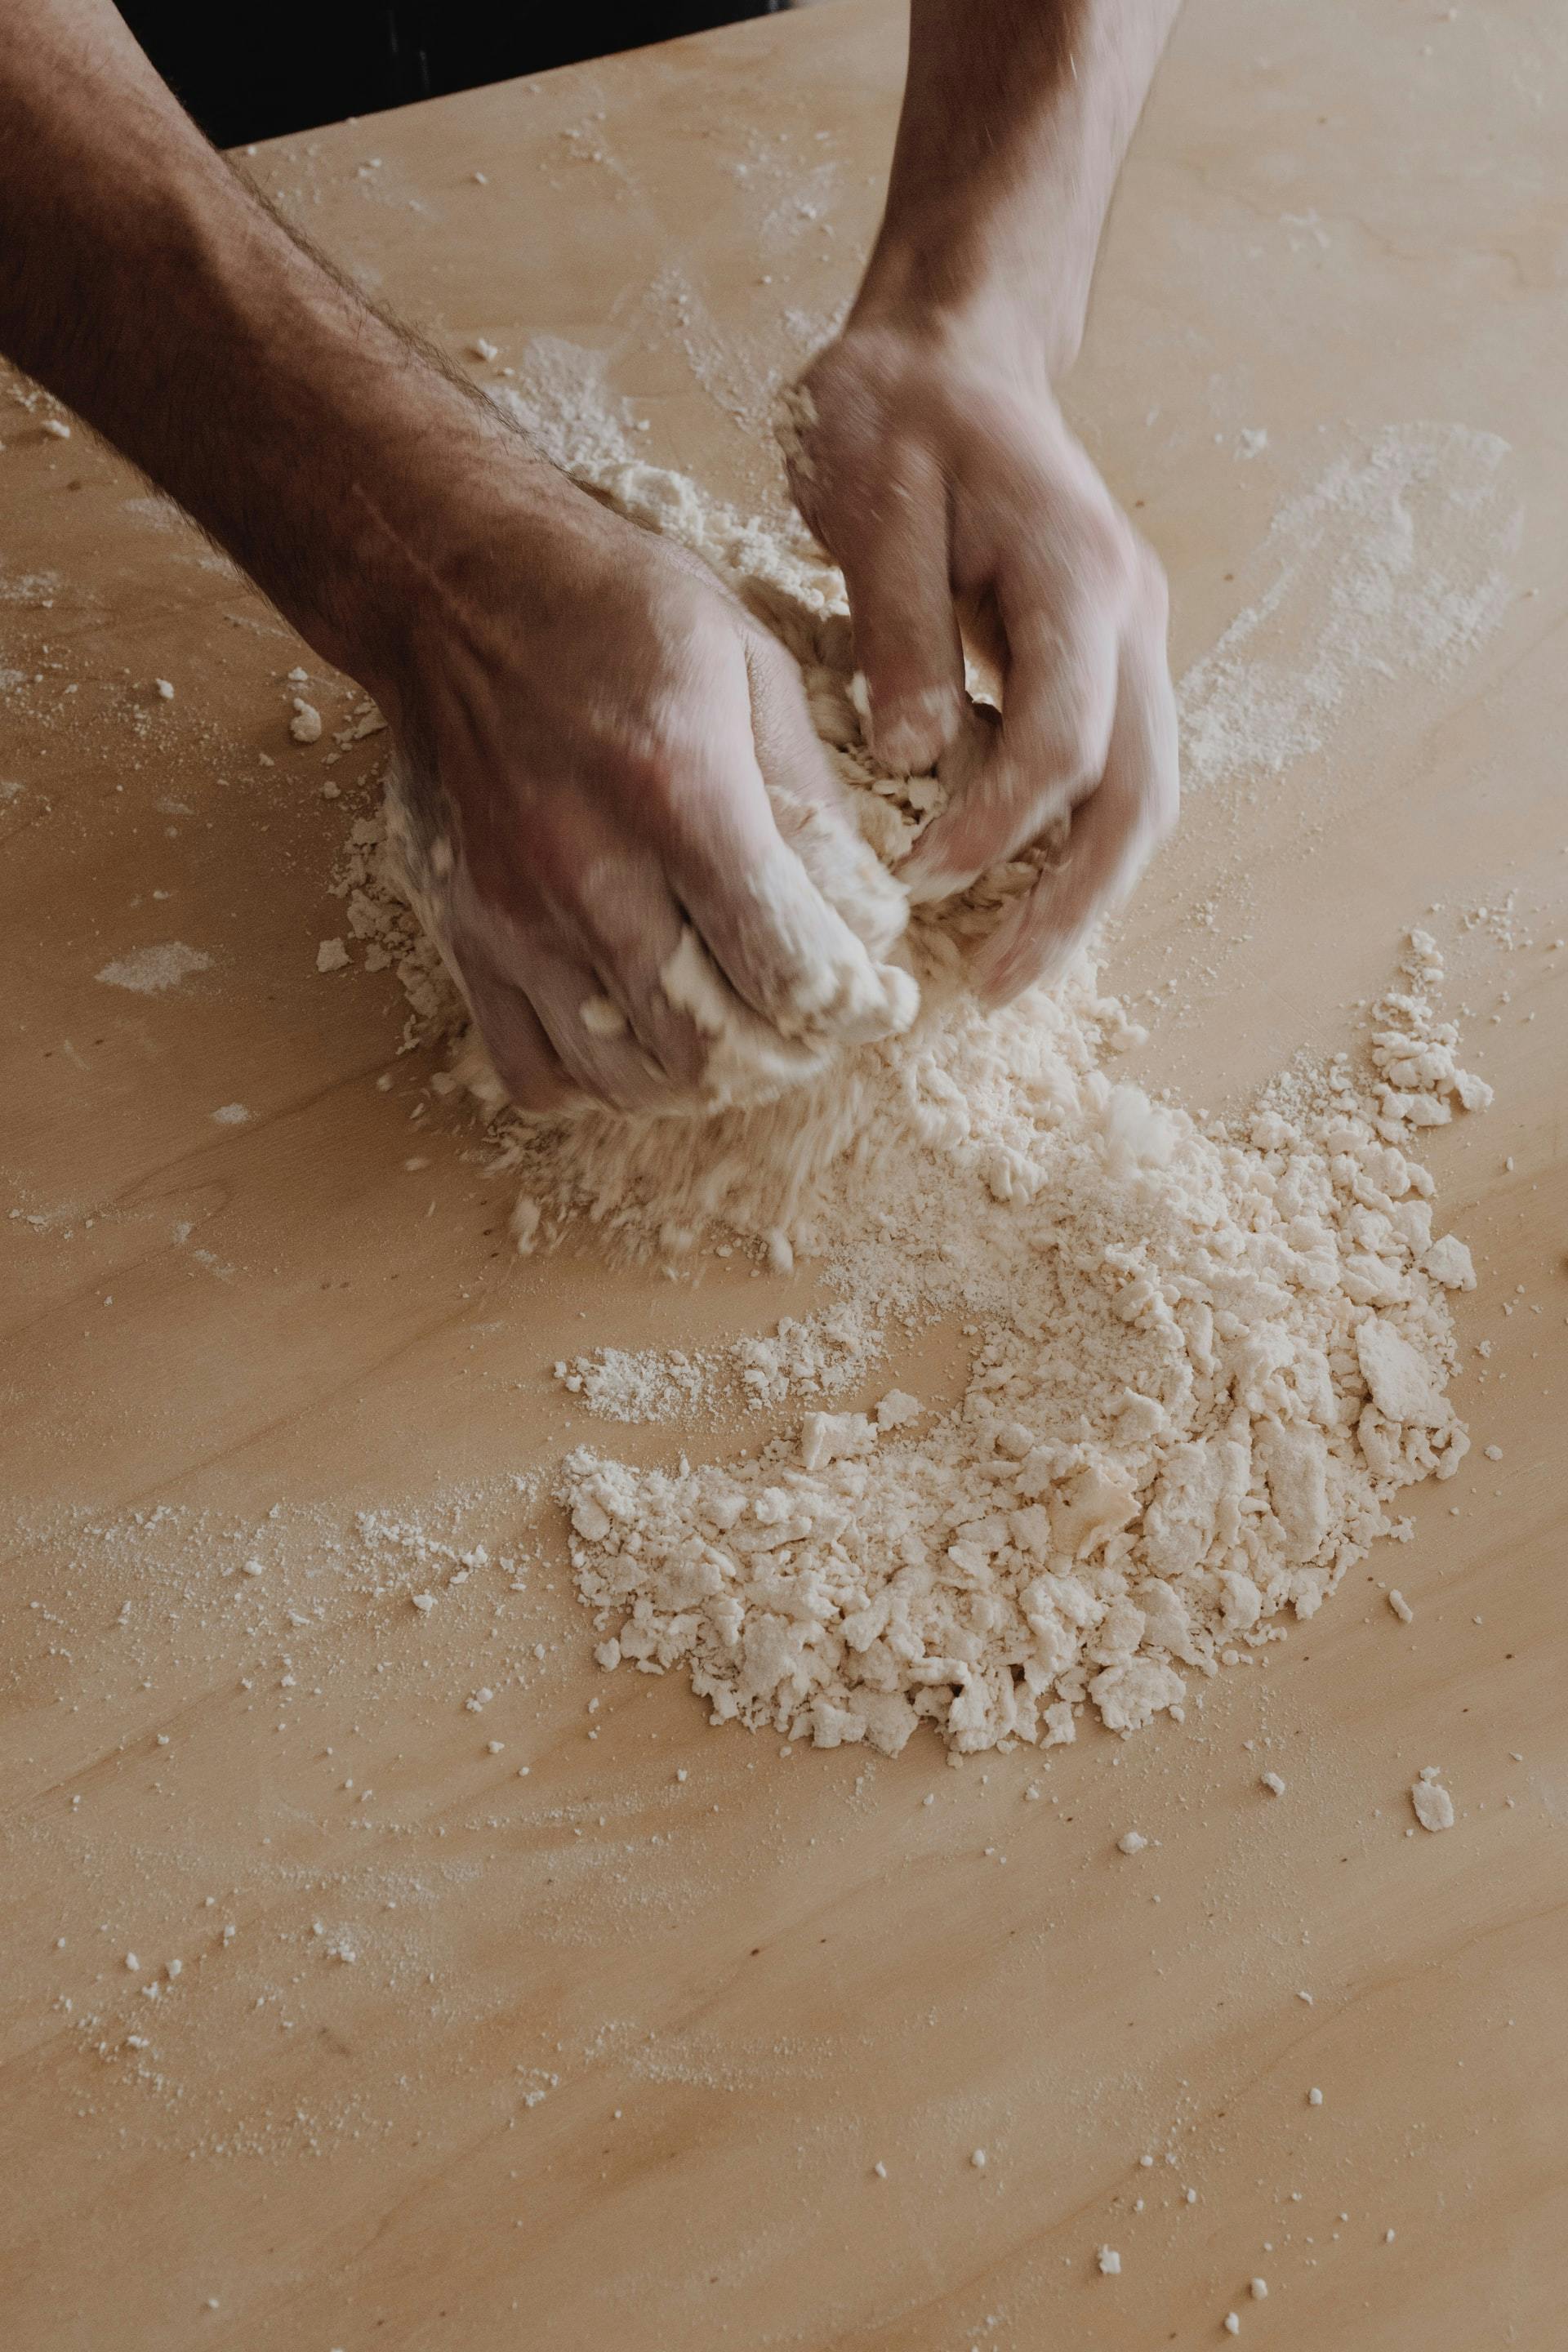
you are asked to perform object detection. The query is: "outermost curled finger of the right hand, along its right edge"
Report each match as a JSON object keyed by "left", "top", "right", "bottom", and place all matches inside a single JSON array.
[{"left": 973, "top": 607, "right": 1180, "bottom": 1004}]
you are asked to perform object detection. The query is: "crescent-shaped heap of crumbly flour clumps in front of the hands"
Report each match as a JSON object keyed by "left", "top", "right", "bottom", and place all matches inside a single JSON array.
[{"left": 569, "top": 907, "right": 1469, "bottom": 1753}]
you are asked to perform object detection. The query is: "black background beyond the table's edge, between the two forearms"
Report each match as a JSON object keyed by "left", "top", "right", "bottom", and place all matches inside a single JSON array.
[{"left": 120, "top": 0, "right": 787, "bottom": 146}]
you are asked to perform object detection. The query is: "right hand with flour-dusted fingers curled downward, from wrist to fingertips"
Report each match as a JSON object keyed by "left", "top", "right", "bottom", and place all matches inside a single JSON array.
[{"left": 790, "top": 318, "right": 1178, "bottom": 1002}]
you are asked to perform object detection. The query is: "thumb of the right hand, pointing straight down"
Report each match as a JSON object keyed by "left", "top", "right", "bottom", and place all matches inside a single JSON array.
[{"left": 832, "top": 444, "right": 964, "bottom": 776}]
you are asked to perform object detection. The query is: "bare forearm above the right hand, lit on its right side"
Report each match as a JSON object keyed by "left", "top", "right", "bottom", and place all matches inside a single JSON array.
[{"left": 856, "top": 0, "right": 1180, "bottom": 376}]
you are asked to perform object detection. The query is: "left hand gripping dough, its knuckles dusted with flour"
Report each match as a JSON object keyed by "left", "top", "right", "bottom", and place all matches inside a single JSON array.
[{"left": 373, "top": 463, "right": 915, "bottom": 1110}]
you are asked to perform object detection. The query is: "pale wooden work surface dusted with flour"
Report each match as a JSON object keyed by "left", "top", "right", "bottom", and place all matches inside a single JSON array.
[{"left": 0, "top": 0, "right": 1568, "bottom": 2352}]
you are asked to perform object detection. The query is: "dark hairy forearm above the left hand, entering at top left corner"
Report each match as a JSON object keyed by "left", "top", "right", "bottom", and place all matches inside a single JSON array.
[{"left": 0, "top": 0, "right": 533, "bottom": 675}]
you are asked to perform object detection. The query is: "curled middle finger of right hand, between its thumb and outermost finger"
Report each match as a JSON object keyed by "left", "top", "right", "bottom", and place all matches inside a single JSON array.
[{"left": 900, "top": 562, "right": 1126, "bottom": 898}]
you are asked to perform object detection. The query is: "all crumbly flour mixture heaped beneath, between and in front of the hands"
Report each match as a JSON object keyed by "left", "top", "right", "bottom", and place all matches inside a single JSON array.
[{"left": 343, "top": 372, "right": 1488, "bottom": 1753}]
